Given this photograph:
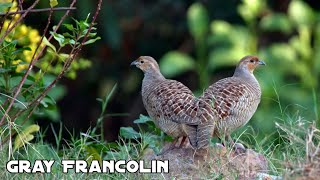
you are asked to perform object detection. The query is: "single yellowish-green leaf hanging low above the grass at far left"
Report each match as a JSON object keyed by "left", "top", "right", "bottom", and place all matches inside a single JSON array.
[{"left": 13, "top": 124, "right": 40, "bottom": 151}]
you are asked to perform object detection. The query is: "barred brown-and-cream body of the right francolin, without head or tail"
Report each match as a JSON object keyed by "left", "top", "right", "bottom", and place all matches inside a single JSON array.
[{"left": 200, "top": 77, "right": 261, "bottom": 132}]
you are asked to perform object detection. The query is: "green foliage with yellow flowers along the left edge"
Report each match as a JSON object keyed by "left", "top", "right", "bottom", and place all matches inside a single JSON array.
[{"left": 0, "top": 1, "right": 100, "bottom": 154}]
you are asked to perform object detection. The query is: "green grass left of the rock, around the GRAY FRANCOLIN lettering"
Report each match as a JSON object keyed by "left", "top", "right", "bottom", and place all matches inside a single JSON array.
[{"left": 0, "top": 129, "right": 151, "bottom": 179}]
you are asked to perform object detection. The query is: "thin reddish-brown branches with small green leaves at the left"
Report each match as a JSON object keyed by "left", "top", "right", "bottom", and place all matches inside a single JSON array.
[{"left": 0, "top": 0, "right": 102, "bottom": 154}]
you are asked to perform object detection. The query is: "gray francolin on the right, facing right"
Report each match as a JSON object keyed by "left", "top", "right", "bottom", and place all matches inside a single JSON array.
[{"left": 197, "top": 56, "right": 265, "bottom": 148}]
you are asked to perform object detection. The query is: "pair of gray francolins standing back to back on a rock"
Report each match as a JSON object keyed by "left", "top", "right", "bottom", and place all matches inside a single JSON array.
[{"left": 131, "top": 56, "right": 264, "bottom": 155}]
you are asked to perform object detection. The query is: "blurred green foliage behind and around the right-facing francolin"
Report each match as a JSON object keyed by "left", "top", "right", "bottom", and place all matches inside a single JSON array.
[{"left": 160, "top": 0, "right": 320, "bottom": 139}]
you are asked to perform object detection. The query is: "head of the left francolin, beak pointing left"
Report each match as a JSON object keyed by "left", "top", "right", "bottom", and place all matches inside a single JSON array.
[{"left": 130, "top": 56, "right": 159, "bottom": 73}]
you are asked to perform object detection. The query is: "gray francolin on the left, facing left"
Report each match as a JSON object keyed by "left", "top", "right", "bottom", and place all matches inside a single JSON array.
[{"left": 131, "top": 56, "right": 197, "bottom": 152}]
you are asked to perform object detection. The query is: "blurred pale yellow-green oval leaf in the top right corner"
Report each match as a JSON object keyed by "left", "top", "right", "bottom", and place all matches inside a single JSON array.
[{"left": 288, "top": 0, "right": 316, "bottom": 26}]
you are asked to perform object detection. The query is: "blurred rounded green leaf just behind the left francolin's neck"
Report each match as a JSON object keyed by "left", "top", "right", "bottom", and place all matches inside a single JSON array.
[{"left": 159, "top": 51, "right": 195, "bottom": 78}]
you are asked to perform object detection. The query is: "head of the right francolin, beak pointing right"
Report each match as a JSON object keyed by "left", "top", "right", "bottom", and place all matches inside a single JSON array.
[{"left": 237, "top": 56, "right": 266, "bottom": 74}]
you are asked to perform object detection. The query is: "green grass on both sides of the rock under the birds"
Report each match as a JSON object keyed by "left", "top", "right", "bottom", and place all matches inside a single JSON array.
[{"left": 0, "top": 87, "right": 320, "bottom": 179}]
